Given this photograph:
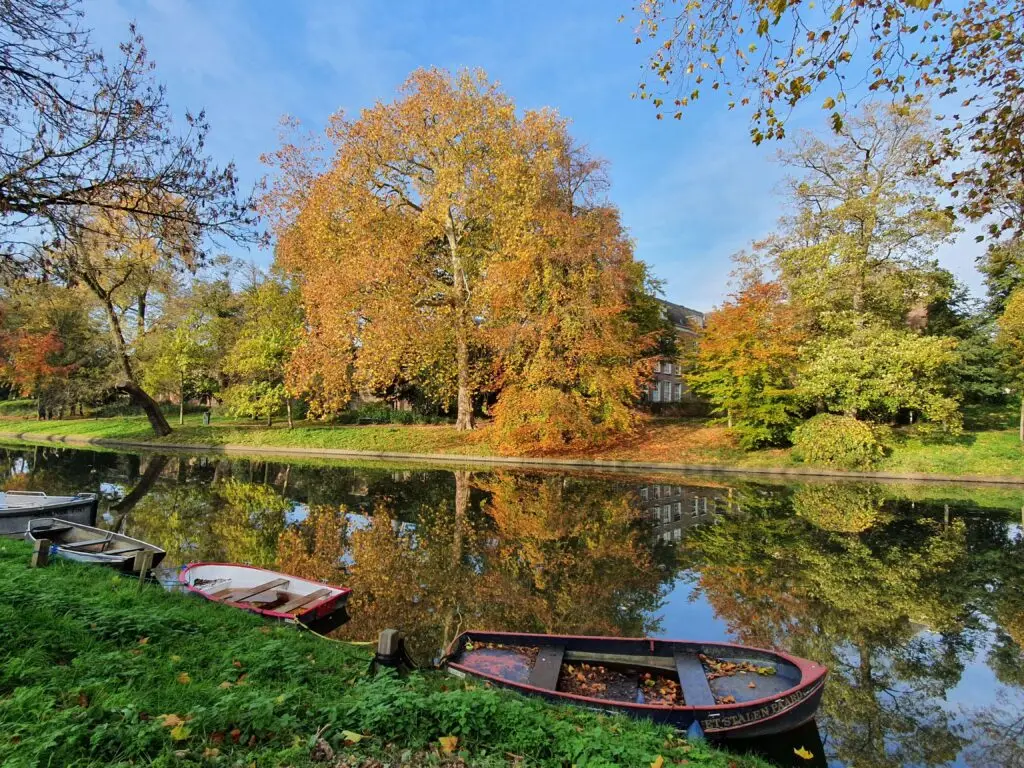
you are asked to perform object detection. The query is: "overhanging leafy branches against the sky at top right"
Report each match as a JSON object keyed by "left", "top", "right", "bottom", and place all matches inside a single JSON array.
[{"left": 635, "top": 0, "right": 1024, "bottom": 233}]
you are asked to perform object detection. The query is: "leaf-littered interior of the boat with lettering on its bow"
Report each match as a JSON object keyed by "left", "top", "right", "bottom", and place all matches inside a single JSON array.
[{"left": 451, "top": 636, "right": 801, "bottom": 707}]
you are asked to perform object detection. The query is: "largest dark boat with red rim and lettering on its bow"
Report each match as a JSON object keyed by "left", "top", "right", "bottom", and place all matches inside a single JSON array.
[{"left": 446, "top": 632, "right": 827, "bottom": 738}]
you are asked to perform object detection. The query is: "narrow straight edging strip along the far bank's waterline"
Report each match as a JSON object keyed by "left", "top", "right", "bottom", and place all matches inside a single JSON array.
[{"left": 0, "top": 432, "right": 1024, "bottom": 486}]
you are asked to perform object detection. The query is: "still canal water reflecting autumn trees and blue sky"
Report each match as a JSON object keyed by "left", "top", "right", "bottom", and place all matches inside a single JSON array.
[{"left": 0, "top": 449, "right": 1024, "bottom": 768}]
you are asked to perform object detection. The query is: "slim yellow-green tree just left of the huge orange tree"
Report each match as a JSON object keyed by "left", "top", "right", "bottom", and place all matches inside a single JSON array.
[{"left": 224, "top": 280, "right": 303, "bottom": 427}]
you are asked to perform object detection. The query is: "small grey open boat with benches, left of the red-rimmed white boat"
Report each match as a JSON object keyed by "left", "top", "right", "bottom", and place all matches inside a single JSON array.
[{"left": 25, "top": 517, "right": 166, "bottom": 573}]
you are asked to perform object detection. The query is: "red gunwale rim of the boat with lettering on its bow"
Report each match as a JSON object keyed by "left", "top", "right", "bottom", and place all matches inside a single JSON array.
[{"left": 445, "top": 630, "right": 828, "bottom": 716}]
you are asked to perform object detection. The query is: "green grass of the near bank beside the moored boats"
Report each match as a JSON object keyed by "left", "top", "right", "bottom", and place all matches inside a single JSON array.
[{"left": 0, "top": 540, "right": 764, "bottom": 768}]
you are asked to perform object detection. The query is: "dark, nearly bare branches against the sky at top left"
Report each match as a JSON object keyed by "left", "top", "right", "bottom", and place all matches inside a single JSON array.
[{"left": 0, "top": 0, "right": 251, "bottom": 272}]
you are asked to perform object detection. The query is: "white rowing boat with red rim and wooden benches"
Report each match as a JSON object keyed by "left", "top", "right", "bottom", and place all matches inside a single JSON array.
[{"left": 178, "top": 562, "right": 352, "bottom": 624}]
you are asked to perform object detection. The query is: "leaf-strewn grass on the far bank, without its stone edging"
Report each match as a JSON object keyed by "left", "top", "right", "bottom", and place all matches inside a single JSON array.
[{"left": 0, "top": 414, "right": 1024, "bottom": 477}]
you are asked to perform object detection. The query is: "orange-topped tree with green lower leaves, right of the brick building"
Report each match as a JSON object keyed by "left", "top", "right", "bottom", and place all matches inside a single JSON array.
[{"left": 687, "top": 279, "right": 806, "bottom": 447}]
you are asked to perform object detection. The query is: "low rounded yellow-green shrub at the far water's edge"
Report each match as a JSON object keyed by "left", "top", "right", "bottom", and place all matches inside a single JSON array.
[{"left": 793, "top": 414, "right": 889, "bottom": 469}]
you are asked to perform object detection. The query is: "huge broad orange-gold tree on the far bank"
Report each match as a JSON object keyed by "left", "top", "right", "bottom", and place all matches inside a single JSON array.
[{"left": 263, "top": 70, "right": 655, "bottom": 442}]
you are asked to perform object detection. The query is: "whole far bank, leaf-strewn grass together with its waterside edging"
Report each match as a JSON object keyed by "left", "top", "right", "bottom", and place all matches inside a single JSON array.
[{"left": 0, "top": 415, "right": 1024, "bottom": 482}]
